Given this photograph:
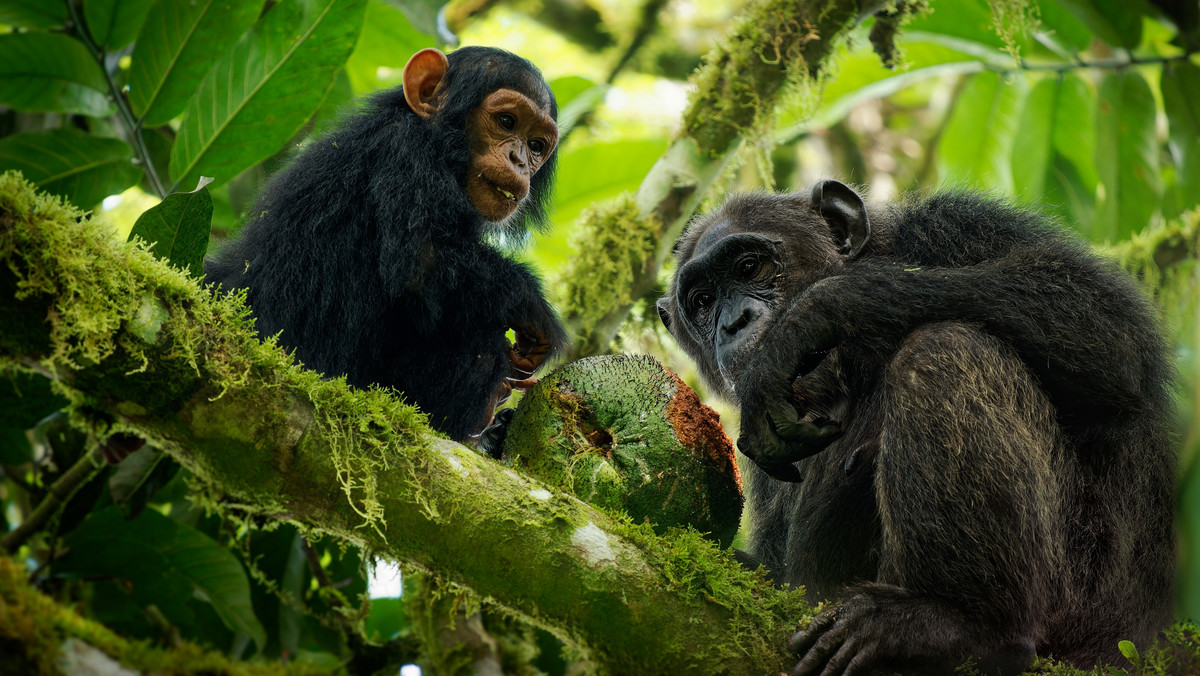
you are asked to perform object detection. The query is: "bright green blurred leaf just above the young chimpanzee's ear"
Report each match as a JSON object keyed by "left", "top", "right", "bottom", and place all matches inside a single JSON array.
[{"left": 346, "top": 0, "right": 438, "bottom": 94}]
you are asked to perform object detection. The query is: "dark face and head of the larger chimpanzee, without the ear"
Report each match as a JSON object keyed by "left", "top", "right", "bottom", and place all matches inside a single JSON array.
[{"left": 658, "top": 195, "right": 842, "bottom": 400}]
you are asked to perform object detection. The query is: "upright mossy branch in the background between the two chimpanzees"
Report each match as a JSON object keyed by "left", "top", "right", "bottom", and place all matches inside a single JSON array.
[{"left": 563, "top": 0, "right": 883, "bottom": 357}]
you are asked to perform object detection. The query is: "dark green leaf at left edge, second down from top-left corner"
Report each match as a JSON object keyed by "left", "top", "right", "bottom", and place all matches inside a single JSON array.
[{"left": 0, "top": 32, "right": 116, "bottom": 118}]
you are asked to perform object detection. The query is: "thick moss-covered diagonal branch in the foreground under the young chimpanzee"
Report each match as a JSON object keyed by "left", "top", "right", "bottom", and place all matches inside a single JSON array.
[{"left": 0, "top": 173, "right": 806, "bottom": 674}]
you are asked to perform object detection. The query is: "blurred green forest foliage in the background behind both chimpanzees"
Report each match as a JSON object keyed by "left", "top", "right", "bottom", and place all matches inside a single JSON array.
[{"left": 0, "top": 0, "right": 1200, "bottom": 672}]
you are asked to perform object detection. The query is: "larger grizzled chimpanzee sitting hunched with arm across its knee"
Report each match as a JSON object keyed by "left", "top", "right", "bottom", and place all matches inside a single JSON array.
[{"left": 659, "top": 181, "right": 1175, "bottom": 674}]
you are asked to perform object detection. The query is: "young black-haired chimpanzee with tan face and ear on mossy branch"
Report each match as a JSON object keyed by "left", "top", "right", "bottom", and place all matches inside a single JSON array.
[{"left": 205, "top": 47, "right": 565, "bottom": 449}]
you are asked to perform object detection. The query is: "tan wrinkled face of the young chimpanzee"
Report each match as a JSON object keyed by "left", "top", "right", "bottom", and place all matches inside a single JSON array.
[{"left": 466, "top": 89, "right": 558, "bottom": 222}]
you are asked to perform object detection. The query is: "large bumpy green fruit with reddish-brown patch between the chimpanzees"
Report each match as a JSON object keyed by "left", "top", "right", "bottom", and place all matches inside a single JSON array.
[{"left": 504, "top": 354, "right": 743, "bottom": 546}]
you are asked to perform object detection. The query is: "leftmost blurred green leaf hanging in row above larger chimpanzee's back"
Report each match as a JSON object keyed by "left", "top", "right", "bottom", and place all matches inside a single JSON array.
[{"left": 937, "top": 72, "right": 1026, "bottom": 193}]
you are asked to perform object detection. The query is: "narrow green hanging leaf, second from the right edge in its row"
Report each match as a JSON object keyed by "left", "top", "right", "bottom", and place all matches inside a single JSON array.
[{"left": 1092, "top": 68, "right": 1163, "bottom": 244}]
